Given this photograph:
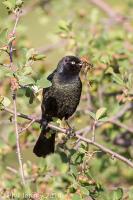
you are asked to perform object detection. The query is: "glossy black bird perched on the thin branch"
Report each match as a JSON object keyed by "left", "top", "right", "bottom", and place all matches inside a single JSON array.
[{"left": 33, "top": 56, "right": 82, "bottom": 157}]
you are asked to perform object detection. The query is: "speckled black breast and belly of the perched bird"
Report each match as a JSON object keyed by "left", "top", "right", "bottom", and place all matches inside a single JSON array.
[{"left": 42, "top": 79, "right": 82, "bottom": 119}]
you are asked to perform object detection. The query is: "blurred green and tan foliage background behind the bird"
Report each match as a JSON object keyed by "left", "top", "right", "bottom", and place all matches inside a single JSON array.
[{"left": 0, "top": 0, "right": 133, "bottom": 200}]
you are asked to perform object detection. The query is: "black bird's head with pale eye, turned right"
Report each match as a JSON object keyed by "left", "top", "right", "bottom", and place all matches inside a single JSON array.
[{"left": 58, "top": 56, "right": 83, "bottom": 75}]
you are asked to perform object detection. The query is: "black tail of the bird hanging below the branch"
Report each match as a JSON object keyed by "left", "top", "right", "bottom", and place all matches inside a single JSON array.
[{"left": 33, "top": 126, "right": 55, "bottom": 157}]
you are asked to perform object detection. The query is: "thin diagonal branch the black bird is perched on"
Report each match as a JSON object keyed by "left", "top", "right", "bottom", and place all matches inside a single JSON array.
[{"left": 4, "top": 108, "right": 133, "bottom": 168}]
